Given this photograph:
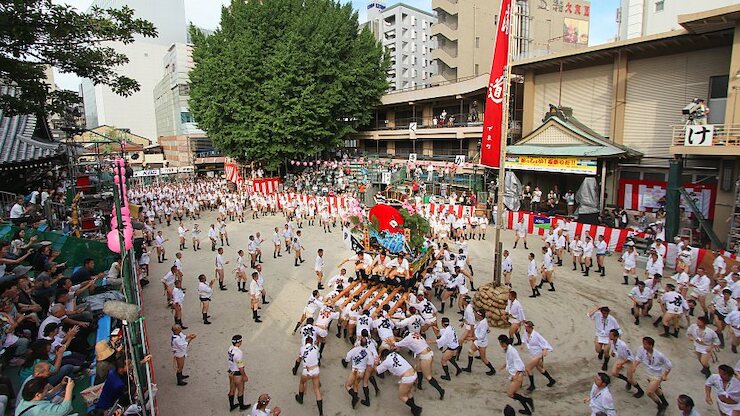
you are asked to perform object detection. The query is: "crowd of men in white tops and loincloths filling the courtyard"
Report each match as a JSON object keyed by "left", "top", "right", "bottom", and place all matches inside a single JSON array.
[{"left": 130, "top": 176, "right": 740, "bottom": 416}]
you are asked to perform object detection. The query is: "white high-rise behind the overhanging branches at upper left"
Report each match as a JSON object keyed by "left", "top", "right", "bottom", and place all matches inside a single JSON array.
[{"left": 82, "top": 0, "right": 188, "bottom": 141}]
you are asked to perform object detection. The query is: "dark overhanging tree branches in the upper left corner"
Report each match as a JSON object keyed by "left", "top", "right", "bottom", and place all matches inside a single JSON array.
[{"left": 0, "top": 0, "right": 157, "bottom": 115}]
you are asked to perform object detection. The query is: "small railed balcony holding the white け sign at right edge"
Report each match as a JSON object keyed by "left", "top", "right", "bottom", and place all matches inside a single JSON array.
[{"left": 670, "top": 124, "right": 740, "bottom": 156}]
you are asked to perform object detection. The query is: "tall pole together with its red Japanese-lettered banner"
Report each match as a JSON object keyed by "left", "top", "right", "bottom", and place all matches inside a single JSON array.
[{"left": 481, "top": 0, "right": 513, "bottom": 287}]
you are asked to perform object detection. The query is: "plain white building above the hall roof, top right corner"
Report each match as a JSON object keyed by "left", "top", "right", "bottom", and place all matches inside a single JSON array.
[{"left": 617, "top": 0, "right": 738, "bottom": 39}]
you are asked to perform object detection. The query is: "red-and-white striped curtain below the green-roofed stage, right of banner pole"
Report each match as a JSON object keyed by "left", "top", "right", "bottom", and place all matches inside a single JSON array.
[{"left": 506, "top": 211, "right": 645, "bottom": 252}]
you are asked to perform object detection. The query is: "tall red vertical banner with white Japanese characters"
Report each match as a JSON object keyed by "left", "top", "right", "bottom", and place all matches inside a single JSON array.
[{"left": 480, "top": 0, "right": 511, "bottom": 168}]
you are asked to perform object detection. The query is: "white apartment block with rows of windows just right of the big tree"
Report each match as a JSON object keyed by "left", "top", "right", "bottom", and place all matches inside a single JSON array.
[{"left": 365, "top": 0, "right": 437, "bottom": 90}]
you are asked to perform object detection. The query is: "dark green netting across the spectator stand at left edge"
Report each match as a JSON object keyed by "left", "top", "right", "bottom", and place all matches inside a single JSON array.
[{"left": 0, "top": 224, "right": 117, "bottom": 272}]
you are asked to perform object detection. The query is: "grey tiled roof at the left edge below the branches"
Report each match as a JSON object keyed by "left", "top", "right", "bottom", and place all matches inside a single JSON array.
[{"left": 0, "top": 112, "right": 64, "bottom": 165}]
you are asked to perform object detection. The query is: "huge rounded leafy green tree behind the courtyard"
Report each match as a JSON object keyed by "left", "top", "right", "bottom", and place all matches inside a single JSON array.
[{"left": 190, "top": 0, "right": 390, "bottom": 166}]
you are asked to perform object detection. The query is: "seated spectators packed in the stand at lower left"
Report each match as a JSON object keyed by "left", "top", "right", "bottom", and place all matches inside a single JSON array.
[{"left": 0, "top": 219, "right": 151, "bottom": 416}]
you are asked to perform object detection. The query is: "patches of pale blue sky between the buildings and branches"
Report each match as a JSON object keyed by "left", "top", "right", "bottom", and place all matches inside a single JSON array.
[{"left": 53, "top": 0, "right": 619, "bottom": 90}]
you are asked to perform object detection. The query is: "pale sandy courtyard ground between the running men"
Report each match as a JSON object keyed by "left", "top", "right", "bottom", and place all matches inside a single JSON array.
[{"left": 144, "top": 213, "right": 737, "bottom": 416}]
